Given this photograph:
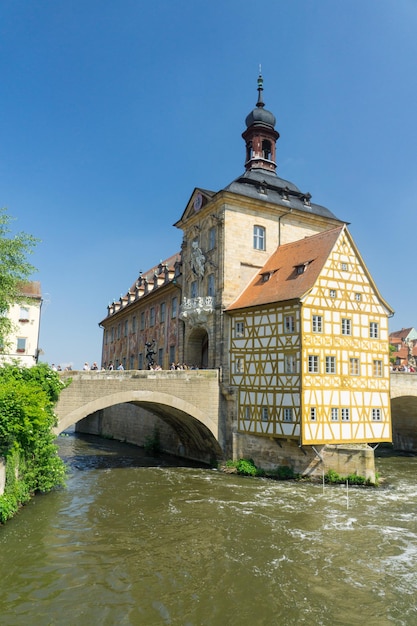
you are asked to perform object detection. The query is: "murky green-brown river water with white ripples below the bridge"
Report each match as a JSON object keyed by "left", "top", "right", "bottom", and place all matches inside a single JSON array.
[{"left": 0, "top": 434, "right": 417, "bottom": 626}]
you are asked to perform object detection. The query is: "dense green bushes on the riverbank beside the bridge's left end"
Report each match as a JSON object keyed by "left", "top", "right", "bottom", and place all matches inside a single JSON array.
[{"left": 0, "top": 364, "right": 66, "bottom": 523}]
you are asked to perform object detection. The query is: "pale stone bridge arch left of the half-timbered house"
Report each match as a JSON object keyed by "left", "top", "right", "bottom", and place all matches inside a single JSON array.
[{"left": 55, "top": 370, "right": 225, "bottom": 461}]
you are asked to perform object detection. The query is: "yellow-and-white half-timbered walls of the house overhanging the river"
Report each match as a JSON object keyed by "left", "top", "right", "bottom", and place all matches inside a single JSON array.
[{"left": 230, "top": 227, "right": 392, "bottom": 445}]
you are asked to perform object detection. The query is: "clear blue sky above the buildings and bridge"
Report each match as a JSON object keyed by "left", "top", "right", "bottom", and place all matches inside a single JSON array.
[{"left": 0, "top": 0, "right": 417, "bottom": 368}]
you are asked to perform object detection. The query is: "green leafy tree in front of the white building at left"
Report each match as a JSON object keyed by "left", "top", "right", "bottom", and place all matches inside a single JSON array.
[{"left": 0, "top": 209, "right": 38, "bottom": 346}]
